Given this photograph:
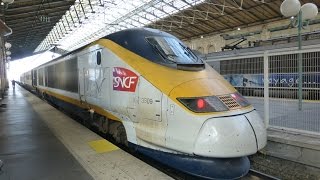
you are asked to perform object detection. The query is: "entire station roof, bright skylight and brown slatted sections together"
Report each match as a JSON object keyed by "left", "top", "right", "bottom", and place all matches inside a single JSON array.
[{"left": 2, "top": 0, "right": 320, "bottom": 60}]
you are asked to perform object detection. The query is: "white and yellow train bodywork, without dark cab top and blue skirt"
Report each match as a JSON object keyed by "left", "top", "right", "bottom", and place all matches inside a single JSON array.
[{"left": 22, "top": 29, "right": 266, "bottom": 178}]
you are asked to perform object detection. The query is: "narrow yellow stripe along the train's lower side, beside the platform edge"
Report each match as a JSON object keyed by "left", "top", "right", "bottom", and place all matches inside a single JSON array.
[{"left": 38, "top": 87, "right": 121, "bottom": 122}]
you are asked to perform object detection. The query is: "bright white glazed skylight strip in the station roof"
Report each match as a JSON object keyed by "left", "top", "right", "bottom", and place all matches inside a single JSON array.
[{"left": 35, "top": 0, "right": 204, "bottom": 52}]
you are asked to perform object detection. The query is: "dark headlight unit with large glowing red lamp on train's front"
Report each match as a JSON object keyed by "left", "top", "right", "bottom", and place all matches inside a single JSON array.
[{"left": 177, "top": 96, "right": 229, "bottom": 113}]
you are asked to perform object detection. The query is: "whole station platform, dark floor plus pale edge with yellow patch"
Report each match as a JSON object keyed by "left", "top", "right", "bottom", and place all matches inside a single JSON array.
[{"left": 0, "top": 86, "right": 172, "bottom": 180}]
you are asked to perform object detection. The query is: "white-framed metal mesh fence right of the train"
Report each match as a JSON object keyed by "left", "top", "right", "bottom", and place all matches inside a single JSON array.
[{"left": 206, "top": 47, "right": 320, "bottom": 134}]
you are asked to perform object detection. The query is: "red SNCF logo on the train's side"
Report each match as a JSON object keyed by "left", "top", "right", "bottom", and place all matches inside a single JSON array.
[{"left": 113, "top": 67, "right": 138, "bottom": 92}]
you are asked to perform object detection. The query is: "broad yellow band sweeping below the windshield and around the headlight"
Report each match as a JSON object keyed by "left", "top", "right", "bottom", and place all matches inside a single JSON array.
[{"left": 92, "top": 39, "right": 252, "bottom": 115}]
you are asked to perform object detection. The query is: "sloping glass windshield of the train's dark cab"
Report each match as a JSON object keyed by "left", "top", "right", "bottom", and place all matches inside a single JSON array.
[{"left": 146, "top": 36, "right": 204, "bottom": 69}]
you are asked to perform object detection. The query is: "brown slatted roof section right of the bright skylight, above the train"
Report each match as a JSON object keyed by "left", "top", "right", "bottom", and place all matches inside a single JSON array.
[{"left": 149, "top": 0, "right": 283, "bottom": 39}]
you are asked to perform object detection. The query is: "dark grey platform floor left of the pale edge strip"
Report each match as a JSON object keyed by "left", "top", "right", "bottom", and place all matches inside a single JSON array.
[{"left": 0, "top": 87, "right": 93, "bottom": 180}]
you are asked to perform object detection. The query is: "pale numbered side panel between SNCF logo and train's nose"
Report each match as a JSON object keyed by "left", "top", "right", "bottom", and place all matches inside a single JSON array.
[{"left": 136, "top": 78, "right": 167, "bottom": 145}]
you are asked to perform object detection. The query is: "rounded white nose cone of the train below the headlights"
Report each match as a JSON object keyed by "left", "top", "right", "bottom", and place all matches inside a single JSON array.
[{"left": 194, "top": 110, "right": 267, "bottom": 158}]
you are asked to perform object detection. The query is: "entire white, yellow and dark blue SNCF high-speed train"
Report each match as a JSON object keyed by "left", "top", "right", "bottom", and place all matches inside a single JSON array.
[{"left": 21, "top": 28, "right": 266, "bottom": 179}]
